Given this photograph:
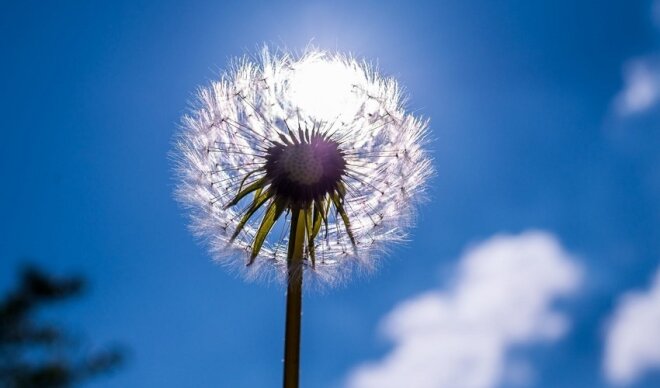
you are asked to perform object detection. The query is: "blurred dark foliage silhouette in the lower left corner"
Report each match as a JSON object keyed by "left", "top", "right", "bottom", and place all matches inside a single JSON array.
[{"left": 0, "top": 266, "right": 124, "bottom": 388}]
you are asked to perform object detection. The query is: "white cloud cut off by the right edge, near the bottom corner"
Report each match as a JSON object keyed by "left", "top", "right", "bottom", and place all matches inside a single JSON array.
[{"left": 604, "top": 270, "right": 660, "bottom": 385}]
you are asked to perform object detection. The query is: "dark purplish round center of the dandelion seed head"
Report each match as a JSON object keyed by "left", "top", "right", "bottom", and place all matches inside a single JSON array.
[{"left": 266, "top": 135, "right": 346, "bottom": 206}]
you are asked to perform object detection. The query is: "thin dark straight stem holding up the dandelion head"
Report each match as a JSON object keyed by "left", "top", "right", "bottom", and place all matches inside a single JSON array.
[{"left": 284, "top": 208, "right": 306, "bottom": 388}]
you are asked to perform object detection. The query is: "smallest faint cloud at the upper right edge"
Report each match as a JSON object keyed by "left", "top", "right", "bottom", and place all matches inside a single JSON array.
[{"left": 616, "top": 59, "right": 660, "bottom": 116}]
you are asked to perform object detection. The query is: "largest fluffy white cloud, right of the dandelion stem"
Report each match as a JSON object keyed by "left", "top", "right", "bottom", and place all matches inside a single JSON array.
[{"left": 347, "top": 232, "right": 580, "bottom": 388}]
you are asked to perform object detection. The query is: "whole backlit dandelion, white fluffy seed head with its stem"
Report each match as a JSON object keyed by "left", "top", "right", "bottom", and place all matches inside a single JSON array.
[{"left": 176, "top": 49, "right": 432, "bottom": 387}]
